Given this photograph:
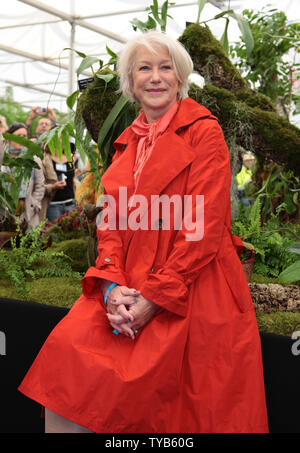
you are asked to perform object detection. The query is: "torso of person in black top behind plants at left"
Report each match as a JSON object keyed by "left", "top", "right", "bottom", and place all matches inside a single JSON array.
[{"left": 41, "top": 141, "right": 75, "bottom": 222}]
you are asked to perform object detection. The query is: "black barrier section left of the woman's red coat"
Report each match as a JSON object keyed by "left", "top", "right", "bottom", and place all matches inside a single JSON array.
[{"left": 0, "top": 298, "right": 68, "bottom": 433}]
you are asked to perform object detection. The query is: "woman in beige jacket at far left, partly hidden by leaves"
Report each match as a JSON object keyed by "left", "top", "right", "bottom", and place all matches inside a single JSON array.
[{"left": 5, "top": 122, "right": 45, "bottom": 228}]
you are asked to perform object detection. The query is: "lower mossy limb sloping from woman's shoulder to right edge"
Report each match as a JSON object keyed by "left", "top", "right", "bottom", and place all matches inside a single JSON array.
[{"left": 189, "top": 85, "right": 300, "bottom": 175}]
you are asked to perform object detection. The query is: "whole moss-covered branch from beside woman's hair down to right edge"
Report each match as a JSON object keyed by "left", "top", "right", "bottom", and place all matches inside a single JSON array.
[{"left": 179, "top": 24, "right": 300, "bottom": 176}]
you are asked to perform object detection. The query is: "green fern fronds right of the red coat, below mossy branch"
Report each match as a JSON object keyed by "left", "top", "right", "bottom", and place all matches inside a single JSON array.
[{"left": 232, "top": 197, "right": 300, "bottom": 278}]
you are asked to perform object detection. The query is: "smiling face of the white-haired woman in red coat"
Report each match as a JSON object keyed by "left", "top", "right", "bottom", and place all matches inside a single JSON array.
[{"left": 132, "top": 45, "right": 181, "bottom": 123}]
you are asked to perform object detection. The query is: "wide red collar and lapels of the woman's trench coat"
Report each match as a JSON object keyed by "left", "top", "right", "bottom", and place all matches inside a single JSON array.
[{"left": 102, "top": 98, "right": 215, "bottom": 203}]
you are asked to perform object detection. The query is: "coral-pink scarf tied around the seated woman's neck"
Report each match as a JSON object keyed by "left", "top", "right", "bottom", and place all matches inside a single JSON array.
[{"left": 131, "top": 100, "right": 180, "bottom": 188}]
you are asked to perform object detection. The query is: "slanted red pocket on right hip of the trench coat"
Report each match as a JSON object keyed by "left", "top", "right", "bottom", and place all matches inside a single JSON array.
[{"left": 217, "top": 249, "right": 254, "bottom": 313}]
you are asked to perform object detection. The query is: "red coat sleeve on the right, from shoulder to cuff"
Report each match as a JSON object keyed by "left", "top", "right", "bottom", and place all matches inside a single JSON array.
[{"left": 139, "top": 120, "right": 231, "bottom": 316}]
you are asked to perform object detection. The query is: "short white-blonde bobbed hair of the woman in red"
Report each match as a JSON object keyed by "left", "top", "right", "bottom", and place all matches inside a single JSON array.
[{"left": 117, "top": 31, "right": 193, "bottom": 101}]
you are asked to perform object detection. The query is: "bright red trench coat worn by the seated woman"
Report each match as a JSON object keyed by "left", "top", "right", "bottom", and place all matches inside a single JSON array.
[{"left": 19, "top": 99, "right": 268, "bottom": 433}]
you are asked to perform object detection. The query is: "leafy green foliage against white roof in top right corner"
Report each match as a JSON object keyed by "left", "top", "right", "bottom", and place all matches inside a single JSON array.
[{"left": 231, "top": 8, "right": 300, "bottom": 118}]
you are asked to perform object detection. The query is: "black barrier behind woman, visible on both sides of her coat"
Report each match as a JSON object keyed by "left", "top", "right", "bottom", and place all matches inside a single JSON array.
[{"left": 0, "top": 298, "right": 300, "bottom": 433}]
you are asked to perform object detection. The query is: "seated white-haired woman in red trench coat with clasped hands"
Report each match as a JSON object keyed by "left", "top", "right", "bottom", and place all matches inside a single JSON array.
[{"left": 20, "top": 32, "right": 268, "bottom": 433}]
